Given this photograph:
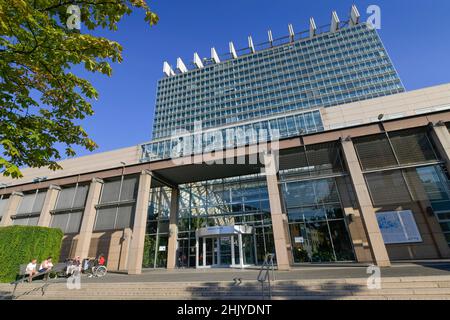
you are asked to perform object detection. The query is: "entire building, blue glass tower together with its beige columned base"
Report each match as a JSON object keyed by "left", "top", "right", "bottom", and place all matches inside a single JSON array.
[{"left": 0, "top": 7, "right": 450, "bottom": 274}]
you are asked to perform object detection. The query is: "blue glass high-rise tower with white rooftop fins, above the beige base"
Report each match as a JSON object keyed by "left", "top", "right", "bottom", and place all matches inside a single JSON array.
[{"left": 144, "top": 9, "right": 404, "bottom": 160}]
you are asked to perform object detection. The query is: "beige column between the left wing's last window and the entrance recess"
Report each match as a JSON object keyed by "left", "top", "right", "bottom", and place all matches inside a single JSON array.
[{"left": 128, "top": 171, "right": 152, "bottom": 274}]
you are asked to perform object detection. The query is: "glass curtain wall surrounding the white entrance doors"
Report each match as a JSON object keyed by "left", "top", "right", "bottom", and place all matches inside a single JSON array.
[{"left": 178, "top": 175, "right": 274, "bottom": 267}]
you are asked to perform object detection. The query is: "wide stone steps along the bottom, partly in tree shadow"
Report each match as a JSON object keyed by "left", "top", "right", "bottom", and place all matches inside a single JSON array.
[{"left": 0, "top": 276, "right": 450, "bottom": 300}]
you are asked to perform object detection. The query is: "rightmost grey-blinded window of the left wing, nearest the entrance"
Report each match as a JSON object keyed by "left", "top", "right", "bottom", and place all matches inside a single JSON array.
[{"left": 94, "top": 176, "right": 138, "bottom": 231}]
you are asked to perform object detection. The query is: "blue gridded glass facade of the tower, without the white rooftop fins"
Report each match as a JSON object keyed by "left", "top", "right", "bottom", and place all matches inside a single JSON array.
[{"left": 153, "top": 24, "right": 404, "bottom": 139}]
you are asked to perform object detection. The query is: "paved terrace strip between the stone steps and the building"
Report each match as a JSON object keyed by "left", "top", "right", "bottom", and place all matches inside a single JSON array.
[{"left": 29, "top": 261, "right": 450, "bottom": 283}]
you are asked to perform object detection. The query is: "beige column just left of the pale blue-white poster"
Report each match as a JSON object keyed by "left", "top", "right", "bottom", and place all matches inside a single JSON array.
[{"left": 342, "top": 140, "right": 391, "bottom": 267}]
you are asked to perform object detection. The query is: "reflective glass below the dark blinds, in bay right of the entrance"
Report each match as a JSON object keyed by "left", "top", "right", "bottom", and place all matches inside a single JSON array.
[{"left": 283, "top": 178, "right": 355, "bottom": 263}]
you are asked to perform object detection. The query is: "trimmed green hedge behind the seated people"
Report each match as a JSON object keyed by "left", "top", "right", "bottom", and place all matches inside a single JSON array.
[{"left": 0, "top": 226, "right": 64, "bottom": 282}]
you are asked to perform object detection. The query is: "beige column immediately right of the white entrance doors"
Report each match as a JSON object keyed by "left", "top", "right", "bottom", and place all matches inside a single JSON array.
[{"left": 264, "top": 154, "right": 291, "bottom": 270}]
